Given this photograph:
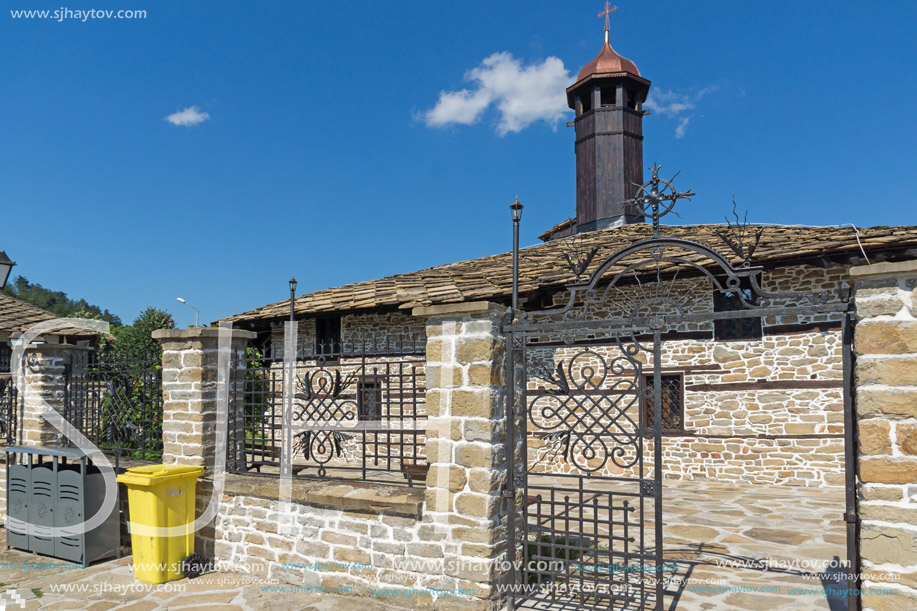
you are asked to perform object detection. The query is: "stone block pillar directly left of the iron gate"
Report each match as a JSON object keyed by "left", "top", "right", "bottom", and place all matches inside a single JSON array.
[{"left": 414, "top": 302, "right": 507, "bottom": 611}]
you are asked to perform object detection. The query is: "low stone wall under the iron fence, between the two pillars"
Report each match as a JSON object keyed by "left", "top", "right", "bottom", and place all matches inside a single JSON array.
[{"left": 215, "top": 475, "right": 448, "bottom": 608}]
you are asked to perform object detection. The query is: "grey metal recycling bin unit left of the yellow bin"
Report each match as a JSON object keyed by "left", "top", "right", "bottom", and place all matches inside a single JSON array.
[{"left": 6, "top": 446, "right": 121, "bottom": 567}]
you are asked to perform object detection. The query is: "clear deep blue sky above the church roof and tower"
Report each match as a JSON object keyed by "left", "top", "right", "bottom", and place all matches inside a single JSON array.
[{"left": 0, "top": 0, "right": 917, "bottom": 326}]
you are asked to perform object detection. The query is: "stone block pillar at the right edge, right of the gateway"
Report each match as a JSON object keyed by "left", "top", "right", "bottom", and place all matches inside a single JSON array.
[{"left": 853, "top": 262, "right": 917, "bottom": 611}]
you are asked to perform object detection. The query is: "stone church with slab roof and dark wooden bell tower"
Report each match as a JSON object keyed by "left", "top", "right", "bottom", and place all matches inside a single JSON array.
[{"left": 229, "top": 15, "right": 917, "bottom": 487}]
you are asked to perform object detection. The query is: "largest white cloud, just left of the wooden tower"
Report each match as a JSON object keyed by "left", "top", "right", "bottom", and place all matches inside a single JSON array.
[{"left": 421, "top": 51, "right": 571, "bottom": 136}]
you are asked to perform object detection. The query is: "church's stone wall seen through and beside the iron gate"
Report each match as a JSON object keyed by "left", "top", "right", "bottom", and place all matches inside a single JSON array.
[{"left": 527, "top": 266, "right": 849, "bottom": 487}]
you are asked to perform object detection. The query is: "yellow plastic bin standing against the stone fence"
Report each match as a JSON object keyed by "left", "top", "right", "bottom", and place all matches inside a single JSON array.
[{"left": 118, "top": 465, "right": 204, "bottom": 584}]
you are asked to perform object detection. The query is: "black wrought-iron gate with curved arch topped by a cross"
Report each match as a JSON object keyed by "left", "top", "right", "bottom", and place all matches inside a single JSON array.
[{"left": 503, "top": 166, "right": 855, "bottom": 611}]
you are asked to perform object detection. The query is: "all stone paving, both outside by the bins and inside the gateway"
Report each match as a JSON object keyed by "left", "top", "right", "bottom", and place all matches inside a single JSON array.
[{"left": 0, "top": 482, "right": 845, "bottom": 611}]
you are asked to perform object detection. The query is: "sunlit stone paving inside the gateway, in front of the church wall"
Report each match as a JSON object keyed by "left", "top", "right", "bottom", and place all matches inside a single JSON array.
[{"left": 648, "top": 482, "right": 847, "bottom": 611}]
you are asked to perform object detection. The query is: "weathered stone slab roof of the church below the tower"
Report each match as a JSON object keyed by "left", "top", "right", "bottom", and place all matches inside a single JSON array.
[{"left": 226, "top": 224, "right": 917, "bottom": 323}]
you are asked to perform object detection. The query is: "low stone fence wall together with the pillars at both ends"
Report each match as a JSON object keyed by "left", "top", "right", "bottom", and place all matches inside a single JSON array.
[{"left": 163, "top": 303, "right": 506, "bottom": 611}]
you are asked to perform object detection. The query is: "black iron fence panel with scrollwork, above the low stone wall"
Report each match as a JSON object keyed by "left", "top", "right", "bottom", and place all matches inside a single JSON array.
[{"left": 233, "top": 334, "right": 427, "bottom": 485}]
